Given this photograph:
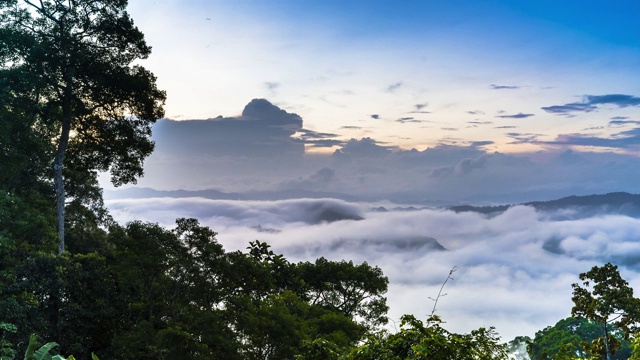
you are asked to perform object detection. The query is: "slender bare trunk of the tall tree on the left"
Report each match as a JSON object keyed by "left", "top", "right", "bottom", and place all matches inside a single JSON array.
[{"left": 53, "top": 70, "right": 73, "bottom": 256}]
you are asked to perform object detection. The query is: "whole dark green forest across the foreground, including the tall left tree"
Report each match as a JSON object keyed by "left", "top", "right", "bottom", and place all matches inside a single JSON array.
[{"left": 0, "top": 0, "right": 640, "bottom": 360}]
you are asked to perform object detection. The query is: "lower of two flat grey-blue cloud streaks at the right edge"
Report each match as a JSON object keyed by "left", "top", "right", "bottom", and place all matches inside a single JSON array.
[{"left": 532, "top": 127, "right": 640, "bottom": 149}]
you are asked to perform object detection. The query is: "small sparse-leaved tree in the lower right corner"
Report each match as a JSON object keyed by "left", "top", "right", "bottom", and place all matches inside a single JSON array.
[{"left": 571, "top": 263, "right": 640, "bottom": 360}]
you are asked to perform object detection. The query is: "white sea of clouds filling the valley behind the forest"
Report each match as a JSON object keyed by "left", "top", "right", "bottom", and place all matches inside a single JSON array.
[{"left": 107, "top": 198, "right": 640, "bottom": 341}]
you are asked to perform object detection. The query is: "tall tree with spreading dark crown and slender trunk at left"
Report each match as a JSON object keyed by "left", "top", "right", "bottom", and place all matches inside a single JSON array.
[{"left": 0, "top": 0, "right": 166, "bottom": 254}]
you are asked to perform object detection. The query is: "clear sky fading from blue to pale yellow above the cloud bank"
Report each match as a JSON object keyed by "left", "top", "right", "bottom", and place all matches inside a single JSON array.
[{"left": 130, "top": 0, "right": 640, "bottom": 154}]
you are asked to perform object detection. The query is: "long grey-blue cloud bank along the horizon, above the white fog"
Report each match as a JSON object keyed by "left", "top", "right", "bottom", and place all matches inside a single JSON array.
[{"left": 126, "top": 95, "right": 640, "bottom": 203}]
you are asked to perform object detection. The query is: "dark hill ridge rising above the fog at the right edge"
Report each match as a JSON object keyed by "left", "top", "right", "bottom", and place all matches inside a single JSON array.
[{"left": 448, "top": 192, "right": 640, "bottom": 218}]
